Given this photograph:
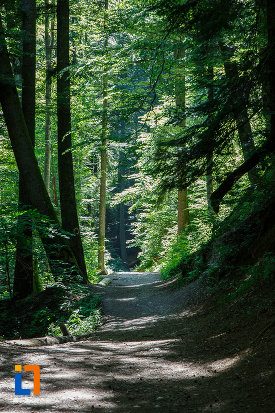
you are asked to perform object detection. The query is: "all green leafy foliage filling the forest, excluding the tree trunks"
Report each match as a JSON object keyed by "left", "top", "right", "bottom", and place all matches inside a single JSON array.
[{"left": 0, "top": 0, "right": 274, "bottom": 337}]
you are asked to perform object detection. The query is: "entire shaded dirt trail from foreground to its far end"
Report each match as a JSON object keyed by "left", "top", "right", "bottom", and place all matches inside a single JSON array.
[{"left": 0, "top": 273, "right": 275, "bottom": 413}]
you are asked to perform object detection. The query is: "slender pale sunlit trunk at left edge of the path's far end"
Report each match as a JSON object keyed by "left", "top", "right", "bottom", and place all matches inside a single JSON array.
[{"left": 98, "top": 0, "right": 109, "bottom": 274}]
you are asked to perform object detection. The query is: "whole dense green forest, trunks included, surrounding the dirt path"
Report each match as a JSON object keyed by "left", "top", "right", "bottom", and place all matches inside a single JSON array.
[{"left": 0, "top": 0, "right": 275, "bottom": 394}]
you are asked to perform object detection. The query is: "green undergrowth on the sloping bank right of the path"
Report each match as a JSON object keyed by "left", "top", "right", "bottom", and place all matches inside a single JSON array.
[{"left": 159, "top": 181, "right": 274, "bottom": 289}]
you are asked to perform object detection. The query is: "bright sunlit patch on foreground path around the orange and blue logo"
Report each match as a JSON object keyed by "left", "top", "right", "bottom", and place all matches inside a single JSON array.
[{"left": 0, "top": 339, "right": 246, "bottom": 412}]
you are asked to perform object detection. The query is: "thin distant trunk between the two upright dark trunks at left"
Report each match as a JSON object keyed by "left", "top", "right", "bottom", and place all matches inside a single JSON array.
[{"left": 44, "top": 0, "right": 54, "bottom": 193}]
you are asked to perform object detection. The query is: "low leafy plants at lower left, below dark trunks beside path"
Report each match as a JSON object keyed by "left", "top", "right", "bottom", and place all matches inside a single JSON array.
[{"left": 0, "top": 283, "right": 102, "bottom": 338}]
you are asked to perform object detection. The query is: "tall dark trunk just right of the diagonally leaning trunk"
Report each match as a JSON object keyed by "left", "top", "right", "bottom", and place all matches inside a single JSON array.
[{"left": 57, "top": 0, "right": 88, "bottom": 281}]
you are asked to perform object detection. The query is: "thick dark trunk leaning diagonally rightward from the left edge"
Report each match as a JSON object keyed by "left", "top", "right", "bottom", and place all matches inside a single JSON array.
[{"left": 0, "top": 15, "right": 84, "bottom": 279}]
